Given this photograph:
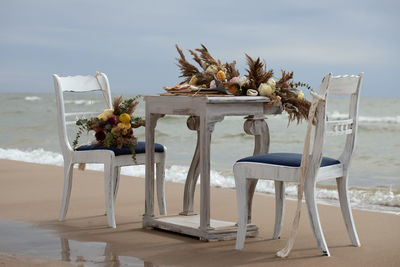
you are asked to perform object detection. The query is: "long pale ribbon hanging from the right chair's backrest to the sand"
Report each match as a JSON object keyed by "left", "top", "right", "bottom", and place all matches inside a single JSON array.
[{"left": 276, "top": 92, "right": 326, "bottom": 258}]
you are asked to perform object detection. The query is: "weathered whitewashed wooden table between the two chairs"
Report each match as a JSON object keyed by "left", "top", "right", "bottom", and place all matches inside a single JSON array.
[{"left": 143, "top": 96, "right": 282, "bottom": 240}]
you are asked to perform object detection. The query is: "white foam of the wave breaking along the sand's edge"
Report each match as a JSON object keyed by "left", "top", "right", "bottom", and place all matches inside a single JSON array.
[{"left": 0, "top": 148, "right": 400, "bottom": 215}]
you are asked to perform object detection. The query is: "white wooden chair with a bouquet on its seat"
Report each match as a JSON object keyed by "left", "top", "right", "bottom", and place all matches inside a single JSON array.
[{"left": 53, "top": 73, "right": 166, "bottom": 228}]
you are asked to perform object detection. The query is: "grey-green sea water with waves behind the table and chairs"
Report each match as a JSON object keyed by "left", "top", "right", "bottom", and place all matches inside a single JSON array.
[{"left": 0, "top": 93, "right": 400, "bottom": 214}]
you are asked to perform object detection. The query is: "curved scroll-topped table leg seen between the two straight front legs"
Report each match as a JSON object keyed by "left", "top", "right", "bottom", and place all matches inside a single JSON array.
[{"left": 180, "top": 116, "right": 200, "bottom": 215}]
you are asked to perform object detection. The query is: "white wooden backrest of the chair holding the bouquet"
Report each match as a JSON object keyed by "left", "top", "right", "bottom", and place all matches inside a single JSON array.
[{"left": 53, "top": 73, "right": 112, "bottom": 156}]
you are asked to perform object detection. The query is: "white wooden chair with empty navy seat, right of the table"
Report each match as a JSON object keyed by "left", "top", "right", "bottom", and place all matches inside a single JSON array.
[{"left": 233, "top": 73, "right": 363, "bottom": 256}]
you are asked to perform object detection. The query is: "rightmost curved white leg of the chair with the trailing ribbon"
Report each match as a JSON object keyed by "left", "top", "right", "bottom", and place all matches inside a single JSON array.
[{"left": 336, "top": 176, "right": 361, "bottom": 247}]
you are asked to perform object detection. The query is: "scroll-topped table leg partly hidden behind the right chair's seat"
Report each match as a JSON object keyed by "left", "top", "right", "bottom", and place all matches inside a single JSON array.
[{"left": 243, "top": 116, "right": 270, "bottom": 223}]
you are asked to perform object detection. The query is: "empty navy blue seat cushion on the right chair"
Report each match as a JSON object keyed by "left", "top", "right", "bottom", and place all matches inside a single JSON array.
[{"left": 237, "top": 153, "right": 340, "bottom": 167}]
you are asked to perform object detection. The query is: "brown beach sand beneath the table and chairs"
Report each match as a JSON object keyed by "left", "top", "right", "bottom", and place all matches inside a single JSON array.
[{"left": 0, "top": 160, "right": 400, "bottom": 266}]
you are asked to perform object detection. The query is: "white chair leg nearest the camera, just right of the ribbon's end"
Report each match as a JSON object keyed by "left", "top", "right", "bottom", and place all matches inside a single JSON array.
[{"left": 304, "top": 180, "right": 330, "bottom": 256}]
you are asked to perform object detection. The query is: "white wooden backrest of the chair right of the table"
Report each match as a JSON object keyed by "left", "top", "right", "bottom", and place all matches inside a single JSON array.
[{"left": 310, "top": 73, "right": 364, "bottom": 174}]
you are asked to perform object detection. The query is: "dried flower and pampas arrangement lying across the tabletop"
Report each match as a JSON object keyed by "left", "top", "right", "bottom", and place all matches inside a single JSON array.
[{"left": 164, "top": 45, "right": 311, "bottom": 122}]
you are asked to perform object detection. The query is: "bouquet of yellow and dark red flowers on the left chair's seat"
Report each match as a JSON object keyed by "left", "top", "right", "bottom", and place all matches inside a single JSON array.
[{"left": 73, "top": 96, "right": 145, "bottom": 160}]
